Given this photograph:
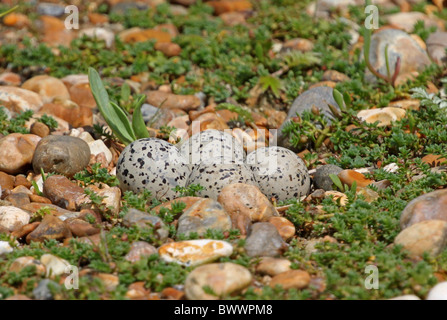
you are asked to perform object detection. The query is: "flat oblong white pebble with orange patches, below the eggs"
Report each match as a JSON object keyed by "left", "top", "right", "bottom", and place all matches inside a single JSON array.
[{"left": 158, "top": 239, "right": 233, "bottom": 267}]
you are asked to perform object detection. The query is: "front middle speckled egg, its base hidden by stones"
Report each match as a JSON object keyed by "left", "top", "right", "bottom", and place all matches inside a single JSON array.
[{"left": 187, "top": 163, "right": 258, "bottom": 200}]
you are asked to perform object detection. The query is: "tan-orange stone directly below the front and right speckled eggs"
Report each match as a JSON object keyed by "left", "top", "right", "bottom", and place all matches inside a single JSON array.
[{"left": 217, "top": 183, "right": 279, "bottom": 234}]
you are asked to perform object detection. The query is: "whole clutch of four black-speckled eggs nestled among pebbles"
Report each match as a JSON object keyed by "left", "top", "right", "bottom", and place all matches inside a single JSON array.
[{"left": 116, "top": 130, "right": 310, "bottom": 200}]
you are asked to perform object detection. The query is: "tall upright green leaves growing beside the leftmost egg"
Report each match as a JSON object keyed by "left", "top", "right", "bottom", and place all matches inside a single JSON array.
[{"left": 88, "top": 68, "right": 149, "bottom": 145}]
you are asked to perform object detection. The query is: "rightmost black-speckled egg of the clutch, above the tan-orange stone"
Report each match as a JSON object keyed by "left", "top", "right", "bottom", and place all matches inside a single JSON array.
[{"left": 246, "top": 147, "right": 310, "bottom": 201}]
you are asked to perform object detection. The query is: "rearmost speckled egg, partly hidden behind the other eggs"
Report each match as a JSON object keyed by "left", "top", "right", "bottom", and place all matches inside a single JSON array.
[{"left": 179, "top": 129, "right": 245, "bottom": 164}]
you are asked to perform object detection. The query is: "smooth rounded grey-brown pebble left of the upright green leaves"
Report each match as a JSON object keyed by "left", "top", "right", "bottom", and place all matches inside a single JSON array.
[{"left": 33, "top": 135, "right": 90, "bottom": 177}]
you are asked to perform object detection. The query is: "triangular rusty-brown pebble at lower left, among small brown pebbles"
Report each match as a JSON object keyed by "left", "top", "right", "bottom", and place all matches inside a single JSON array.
[{"left": 26, "top": 215, "right": 71, "bottom": 243}]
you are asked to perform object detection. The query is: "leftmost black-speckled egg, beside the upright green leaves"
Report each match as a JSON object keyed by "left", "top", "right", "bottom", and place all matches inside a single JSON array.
[{"left": 116, "top": 138, "right": 190, "bottom": 200}]
